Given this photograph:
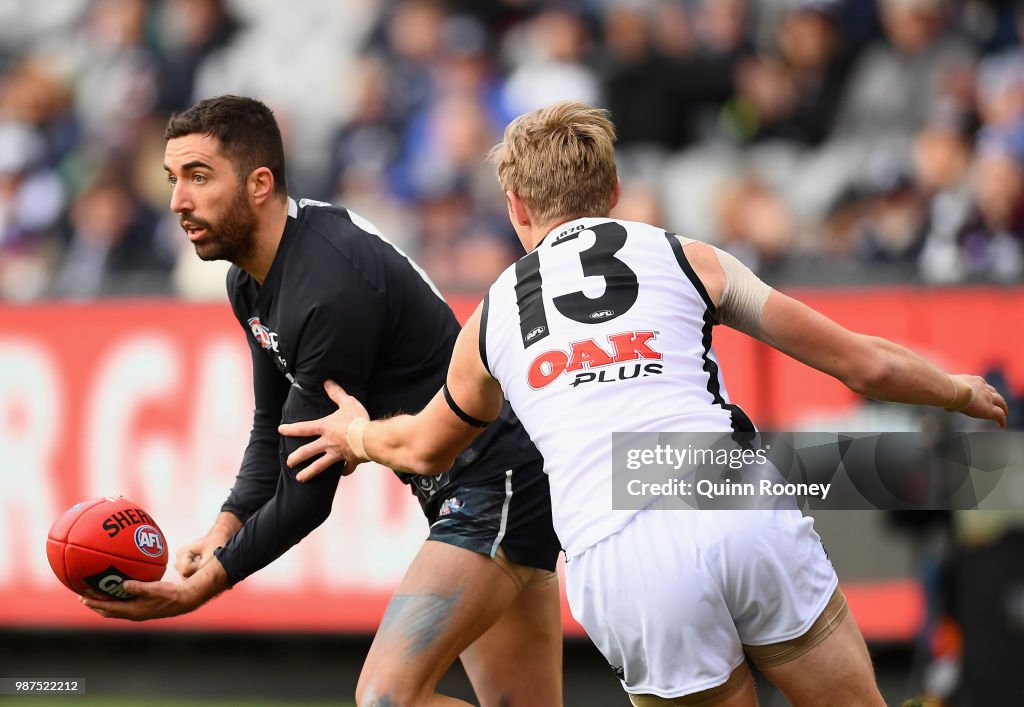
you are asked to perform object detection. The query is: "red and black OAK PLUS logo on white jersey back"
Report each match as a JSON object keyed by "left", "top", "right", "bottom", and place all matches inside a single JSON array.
[{"left": 527, "top": 331, "right": 663, "bottom": 390}]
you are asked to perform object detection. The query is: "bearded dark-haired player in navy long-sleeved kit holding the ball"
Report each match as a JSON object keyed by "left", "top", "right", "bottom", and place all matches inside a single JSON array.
[{"left": 84, "top": 95, "right": 561, "bottom": 706}]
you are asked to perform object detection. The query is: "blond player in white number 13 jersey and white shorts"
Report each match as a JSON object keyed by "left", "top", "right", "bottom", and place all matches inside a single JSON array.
[{"left": 281, "top": 101, "right": 1007, "bottom": 707}]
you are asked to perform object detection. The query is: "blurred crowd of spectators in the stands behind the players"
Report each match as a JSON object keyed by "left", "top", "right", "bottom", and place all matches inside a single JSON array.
[{"left": 0, "top": 0, "right": 1024, "bottom": 300}]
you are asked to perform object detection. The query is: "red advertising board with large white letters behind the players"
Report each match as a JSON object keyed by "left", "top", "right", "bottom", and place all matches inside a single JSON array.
[{"left": 0, "top": 289, "right": 1024, "bottom": 638}]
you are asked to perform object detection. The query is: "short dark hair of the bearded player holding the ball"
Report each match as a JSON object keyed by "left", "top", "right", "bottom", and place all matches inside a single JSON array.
[{"left": 164, "top": 95, "right": 288, "bottom": 196}]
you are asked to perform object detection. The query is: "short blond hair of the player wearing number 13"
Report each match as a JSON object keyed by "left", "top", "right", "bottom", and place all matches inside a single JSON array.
[{"left": 487, "top": 100, "right": 618, "bottom": 224}]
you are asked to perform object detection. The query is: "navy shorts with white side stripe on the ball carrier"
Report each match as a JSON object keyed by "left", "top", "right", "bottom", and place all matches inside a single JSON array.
[{"left": 424, "top": 460, "right": 561, "bottom": 572}]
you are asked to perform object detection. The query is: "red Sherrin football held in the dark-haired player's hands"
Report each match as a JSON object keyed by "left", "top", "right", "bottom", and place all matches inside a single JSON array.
[{"left": 46, "top": 496, "right": 167, "bottom": 599}]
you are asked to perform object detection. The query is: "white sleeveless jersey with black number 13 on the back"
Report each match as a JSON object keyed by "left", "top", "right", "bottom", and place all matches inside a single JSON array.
[{"left": 480, "top": 218, "right": 753, "bottom": 556}]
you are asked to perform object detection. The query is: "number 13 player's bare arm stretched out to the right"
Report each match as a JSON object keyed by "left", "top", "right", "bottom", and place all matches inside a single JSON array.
[{"left": 685, "top": 236, "right": 1007, "bottom": 426}]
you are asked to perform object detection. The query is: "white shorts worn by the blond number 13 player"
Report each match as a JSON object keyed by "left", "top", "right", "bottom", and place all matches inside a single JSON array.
[{"left": 565, "top": 509, "right": 839, "bottom": 698}]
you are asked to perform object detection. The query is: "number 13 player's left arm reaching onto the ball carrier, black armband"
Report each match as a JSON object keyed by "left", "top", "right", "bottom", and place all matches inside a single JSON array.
[{"left": 280, "top": 307, "right": 504, "bottom": 482}]
